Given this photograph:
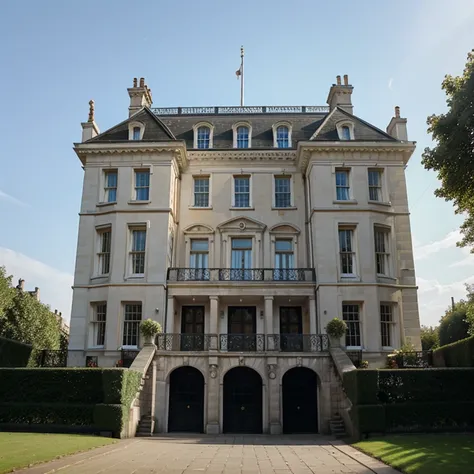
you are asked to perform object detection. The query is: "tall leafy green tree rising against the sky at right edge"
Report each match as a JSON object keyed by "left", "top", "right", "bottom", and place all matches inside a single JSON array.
[{"left": 422, "top": 50, "right": 474, "bottom": 252}]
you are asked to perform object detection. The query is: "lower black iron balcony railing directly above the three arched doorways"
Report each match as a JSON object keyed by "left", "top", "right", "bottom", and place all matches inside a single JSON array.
[{"left": 156, "top": 333, "right": 329, "bottom": 352}]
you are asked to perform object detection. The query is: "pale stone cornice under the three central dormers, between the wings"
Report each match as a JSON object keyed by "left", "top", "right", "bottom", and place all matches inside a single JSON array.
[{"left": 188, "top": 148, "right": 297, "bottom": 162}]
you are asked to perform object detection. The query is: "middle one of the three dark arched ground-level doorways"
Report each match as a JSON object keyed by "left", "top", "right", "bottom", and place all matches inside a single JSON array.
[{"left": 223, "top": 367, "right": 262, "bottom": 433}]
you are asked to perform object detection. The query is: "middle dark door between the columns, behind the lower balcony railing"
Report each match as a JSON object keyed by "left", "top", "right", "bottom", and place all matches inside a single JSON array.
[{"left": 227, "top": 306, "right": 257, "bottom": 352}]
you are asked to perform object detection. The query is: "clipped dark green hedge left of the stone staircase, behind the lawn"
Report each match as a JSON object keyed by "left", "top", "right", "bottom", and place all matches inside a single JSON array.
[{"left": 0, "top": 368, "right": 142, "bottom": 437}]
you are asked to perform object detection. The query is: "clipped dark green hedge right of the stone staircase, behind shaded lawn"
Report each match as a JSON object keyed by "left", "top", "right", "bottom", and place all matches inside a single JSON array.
[{"left": 344, "top": 368, "right": 474, "bottom": 436}]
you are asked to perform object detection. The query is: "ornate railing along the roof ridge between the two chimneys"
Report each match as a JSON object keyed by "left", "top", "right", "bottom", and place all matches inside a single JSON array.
[{"left": 151, "top": 105, "right": 329, "bottom": 116}]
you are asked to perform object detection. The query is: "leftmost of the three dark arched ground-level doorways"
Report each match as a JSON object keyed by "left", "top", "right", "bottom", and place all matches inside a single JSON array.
[{"left": 168, "top": 367, "right": 204, "bottom": 433}]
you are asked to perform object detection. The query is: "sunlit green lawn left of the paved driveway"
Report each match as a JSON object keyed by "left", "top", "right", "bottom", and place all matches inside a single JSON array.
[{"left": 0, "top": 433, "right": 116, "bottom": 474}]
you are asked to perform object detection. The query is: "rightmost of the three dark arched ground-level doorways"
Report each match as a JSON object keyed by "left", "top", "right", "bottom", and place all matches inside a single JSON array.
[{"left": 282, "top": 367, "right": 318, "bottom": 433}]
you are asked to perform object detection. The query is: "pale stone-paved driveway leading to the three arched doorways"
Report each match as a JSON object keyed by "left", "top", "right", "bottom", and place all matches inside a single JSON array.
[{"left": 16, "top": 435, "right": 398, "bottom": 474}]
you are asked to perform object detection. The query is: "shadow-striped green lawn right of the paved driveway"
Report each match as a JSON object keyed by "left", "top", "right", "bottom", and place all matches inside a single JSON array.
[{"left": 354, "top": 434, "right": 474, "bottom": 474}]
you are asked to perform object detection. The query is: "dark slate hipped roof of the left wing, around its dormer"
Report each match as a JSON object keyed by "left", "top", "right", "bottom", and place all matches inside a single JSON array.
[{"left": 87, "top": 107, "right": 176, "bottom": 143}]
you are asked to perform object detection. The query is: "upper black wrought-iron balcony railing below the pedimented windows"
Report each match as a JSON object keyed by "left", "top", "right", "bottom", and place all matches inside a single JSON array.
[{"left": 168, "top": 268, "right": 316, "bottom": 282}]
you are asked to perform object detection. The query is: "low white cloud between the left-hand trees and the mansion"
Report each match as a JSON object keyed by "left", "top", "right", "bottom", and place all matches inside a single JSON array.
[{"left": 0, "top": 247, "right": 74, "bottom": 321}]
